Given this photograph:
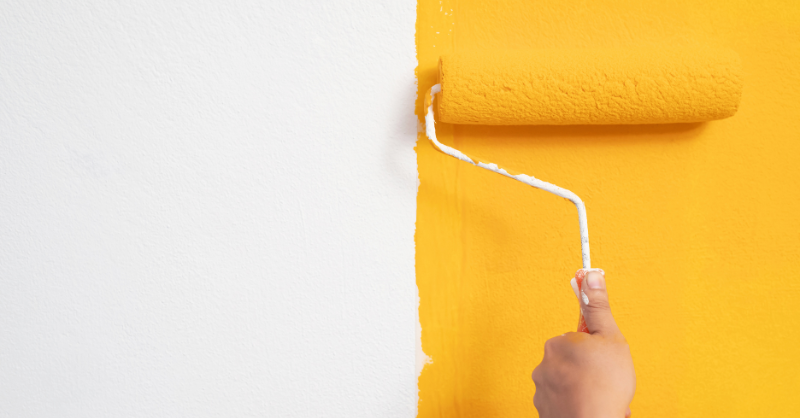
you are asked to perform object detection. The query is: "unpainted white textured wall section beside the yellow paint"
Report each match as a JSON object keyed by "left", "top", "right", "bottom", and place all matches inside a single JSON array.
[{"left": 0, "top": 0, "right": 417, "bottom": 417}]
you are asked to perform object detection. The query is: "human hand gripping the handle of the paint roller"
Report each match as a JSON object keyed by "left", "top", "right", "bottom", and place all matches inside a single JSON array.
[{"left": 532, "top": 271, "right": 636, "bottom": 418}]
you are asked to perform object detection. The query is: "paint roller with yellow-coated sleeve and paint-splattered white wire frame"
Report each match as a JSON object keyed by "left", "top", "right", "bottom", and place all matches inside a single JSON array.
[{"left": 425, "top": 47, "right": 742, "bottom": 332}]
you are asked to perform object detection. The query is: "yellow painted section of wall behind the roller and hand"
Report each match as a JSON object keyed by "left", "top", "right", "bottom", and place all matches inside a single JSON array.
[{"left": 416, "top": 0, "right": 800, "bottom": 418}]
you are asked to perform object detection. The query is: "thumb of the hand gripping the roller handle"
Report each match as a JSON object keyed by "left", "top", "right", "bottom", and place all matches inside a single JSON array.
[{"left": 577, "top": 269, "right": 620, "bottom": 335}]
